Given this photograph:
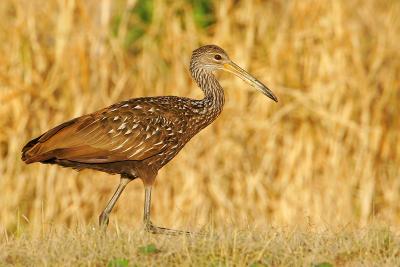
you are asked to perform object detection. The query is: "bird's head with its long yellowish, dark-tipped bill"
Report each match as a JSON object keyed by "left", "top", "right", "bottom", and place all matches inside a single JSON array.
[{"left": 190, "top": 45, "right": 278, "bottom": 102}]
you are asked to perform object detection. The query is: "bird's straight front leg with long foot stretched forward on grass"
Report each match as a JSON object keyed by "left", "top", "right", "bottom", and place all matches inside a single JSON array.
[{"left": 143, "top": 185, "right": 191, "bottom": 235}]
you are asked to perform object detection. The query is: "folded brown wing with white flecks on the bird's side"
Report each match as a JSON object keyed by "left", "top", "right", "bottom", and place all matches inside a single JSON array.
[{"left": 27, "top": 103, "right": 174, "bottom": 163}]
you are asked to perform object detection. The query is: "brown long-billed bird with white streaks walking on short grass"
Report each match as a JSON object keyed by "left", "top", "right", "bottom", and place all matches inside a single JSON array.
[{"left": 21, "top": 45, "right": 278, "bottom": 235}]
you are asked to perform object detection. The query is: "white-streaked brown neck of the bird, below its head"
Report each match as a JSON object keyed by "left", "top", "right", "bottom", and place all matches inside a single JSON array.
[{"left": 192, "top": 70, "right": 225, "bottom": 118}]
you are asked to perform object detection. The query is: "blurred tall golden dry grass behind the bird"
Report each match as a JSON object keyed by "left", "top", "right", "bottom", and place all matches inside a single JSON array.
[{"left": 0, "top": 0, "right": 400, "bottom": 232}]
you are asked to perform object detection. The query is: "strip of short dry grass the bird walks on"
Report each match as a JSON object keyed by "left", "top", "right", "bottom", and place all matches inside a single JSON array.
[{"left": 0, "top": 227, "right": 400, "bottom": 267}]
